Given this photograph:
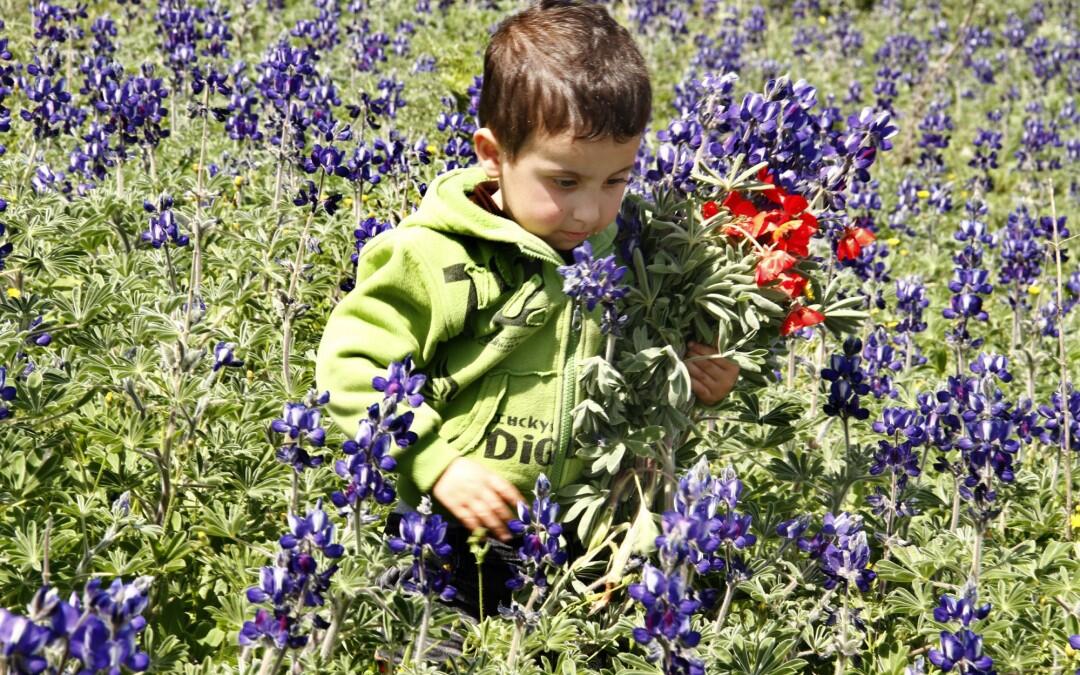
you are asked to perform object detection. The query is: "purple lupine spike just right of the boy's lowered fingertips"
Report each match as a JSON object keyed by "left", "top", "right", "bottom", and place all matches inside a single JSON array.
[{"left": 507, "top": 473, "right": 567, "bottom": 593}]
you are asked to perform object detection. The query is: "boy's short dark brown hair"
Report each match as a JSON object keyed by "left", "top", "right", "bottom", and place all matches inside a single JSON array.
[{"left": 478, "top": 0, "right": 652, "bottom": 160}]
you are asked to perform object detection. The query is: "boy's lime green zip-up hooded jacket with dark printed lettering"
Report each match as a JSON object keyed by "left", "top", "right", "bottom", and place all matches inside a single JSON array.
[{"left": 315, "top": 167, "right": 616, "bottom": 513}]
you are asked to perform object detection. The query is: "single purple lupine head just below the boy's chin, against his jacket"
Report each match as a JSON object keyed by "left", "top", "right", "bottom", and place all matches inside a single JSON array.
[{"left": 558, "top": 242, "right": 629, "bottom": 363}]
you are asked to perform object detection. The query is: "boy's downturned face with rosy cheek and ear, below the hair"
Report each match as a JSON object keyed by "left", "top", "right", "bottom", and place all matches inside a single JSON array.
[{"left": 473, "top": 127, "right": 642, "bottom": 251}]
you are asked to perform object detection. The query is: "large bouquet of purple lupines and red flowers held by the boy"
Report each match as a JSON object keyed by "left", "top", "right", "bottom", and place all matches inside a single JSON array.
[{"left": 563, "top": 75, "right": 896, "bottom": 575}]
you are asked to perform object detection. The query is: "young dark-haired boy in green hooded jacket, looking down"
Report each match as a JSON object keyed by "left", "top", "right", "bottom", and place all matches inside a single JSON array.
[{"left": 315, "top": 0, "right": 738, "bottom": 618}]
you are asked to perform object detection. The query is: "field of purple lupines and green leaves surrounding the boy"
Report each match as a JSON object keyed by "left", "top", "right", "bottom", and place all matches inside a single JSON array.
[{"left": 0, "top": 0, "right": 1080, "bottom": 675}]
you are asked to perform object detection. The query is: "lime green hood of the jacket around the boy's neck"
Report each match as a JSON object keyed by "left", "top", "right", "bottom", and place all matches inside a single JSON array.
[{"left": 397, "top": 166, "right": 616, "bottom": 265}]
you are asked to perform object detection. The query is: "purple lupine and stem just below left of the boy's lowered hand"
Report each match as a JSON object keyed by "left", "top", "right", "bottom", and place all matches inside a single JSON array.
[{"left": 387, "top": 495, "right": 457, "bottom": 665}]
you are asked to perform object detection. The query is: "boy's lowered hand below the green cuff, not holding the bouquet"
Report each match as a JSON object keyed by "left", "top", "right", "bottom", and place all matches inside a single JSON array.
[{"left": 431, "top": 457, "right": 525, "bottom": 541}]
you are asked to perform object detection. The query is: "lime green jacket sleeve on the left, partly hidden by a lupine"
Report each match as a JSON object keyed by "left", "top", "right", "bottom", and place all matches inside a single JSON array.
[{"left": 315, "top": 228, "right": 459, "bottom": 494}]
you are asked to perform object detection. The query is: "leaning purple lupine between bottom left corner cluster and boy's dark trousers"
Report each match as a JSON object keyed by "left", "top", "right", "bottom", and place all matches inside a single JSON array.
[{"left": 240, "top": 500, "right": 345, "bottom": 675}]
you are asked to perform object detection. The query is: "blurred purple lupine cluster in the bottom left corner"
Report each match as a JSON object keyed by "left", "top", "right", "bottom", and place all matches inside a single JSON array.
[{"left": 0, "top": 577, "right": 153, "bottom": 675}]
